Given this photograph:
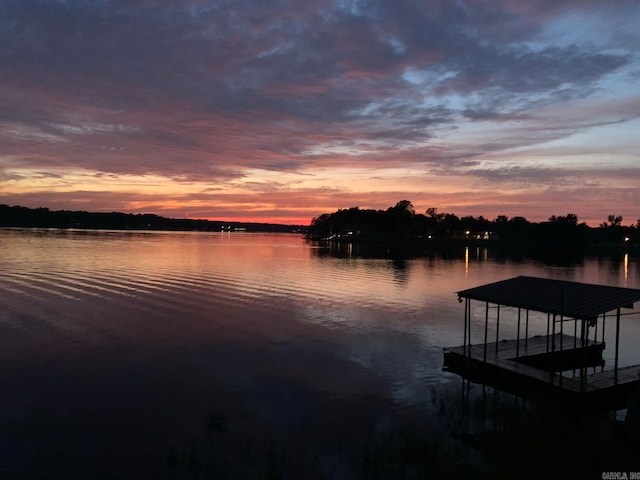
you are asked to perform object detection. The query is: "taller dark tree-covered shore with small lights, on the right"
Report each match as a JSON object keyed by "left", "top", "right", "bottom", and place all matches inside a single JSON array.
[{"left": 308, "top": 200, "right": 640, "bottom": 253}]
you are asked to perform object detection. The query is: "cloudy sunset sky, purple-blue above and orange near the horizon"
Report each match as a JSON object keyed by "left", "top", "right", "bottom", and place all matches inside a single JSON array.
[{"left": 0, "top": 0, "right": 640, "bottom": 225}]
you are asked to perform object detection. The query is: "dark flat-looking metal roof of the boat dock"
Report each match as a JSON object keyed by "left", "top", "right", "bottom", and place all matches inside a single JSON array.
[{"left": 458, "top": 276, "right": 640, "bottom": 319}]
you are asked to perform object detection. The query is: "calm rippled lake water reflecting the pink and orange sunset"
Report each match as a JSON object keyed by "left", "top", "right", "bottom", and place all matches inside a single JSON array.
[{"left": 0, "top": 230, "right": 640, "bottom": 478}]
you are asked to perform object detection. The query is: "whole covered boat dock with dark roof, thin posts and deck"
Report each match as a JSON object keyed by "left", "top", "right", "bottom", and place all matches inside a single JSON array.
[{"left": 444, "top": 276, "right": 640, "bottom": 408}]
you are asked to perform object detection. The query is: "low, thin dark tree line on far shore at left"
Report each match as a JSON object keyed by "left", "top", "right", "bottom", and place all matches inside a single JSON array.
[{"left": 0, "top": 204, "right": 306, "bottom": 232}]
